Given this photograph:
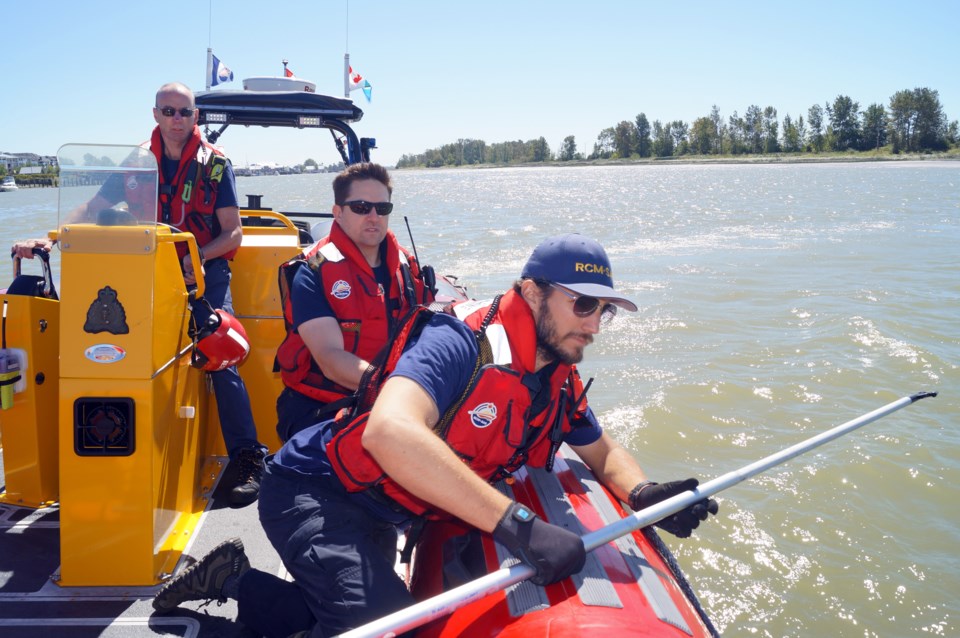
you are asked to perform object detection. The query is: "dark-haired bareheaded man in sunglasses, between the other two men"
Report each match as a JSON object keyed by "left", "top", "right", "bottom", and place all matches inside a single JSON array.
[{"left": 277, "top": 163, "right": 432, "bottom": 441}]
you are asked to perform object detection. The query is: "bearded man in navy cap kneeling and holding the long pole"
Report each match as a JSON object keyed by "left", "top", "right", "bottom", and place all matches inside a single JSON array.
[{"left": 154, "top": 234, "right": 717, "bottom": 637}]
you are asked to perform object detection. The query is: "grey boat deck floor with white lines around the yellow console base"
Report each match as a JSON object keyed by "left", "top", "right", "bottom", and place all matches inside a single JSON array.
[{"left": 0, "top": 453, "right": 276, "bottom": 638}]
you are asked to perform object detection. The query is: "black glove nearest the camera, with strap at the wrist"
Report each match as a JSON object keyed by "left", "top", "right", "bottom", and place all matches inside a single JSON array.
[{"left": 493, "top": 503, "right": 587, "bottom": 585}]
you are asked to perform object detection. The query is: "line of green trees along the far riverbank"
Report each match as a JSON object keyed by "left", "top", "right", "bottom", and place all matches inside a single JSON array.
[{"left": 397, "top": 88, "right": 960, "bottom": 168}]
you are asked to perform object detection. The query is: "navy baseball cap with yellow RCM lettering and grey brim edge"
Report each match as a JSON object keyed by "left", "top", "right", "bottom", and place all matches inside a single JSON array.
[{"left": 520, "top": 233, "right": 637, "bottom": 312}]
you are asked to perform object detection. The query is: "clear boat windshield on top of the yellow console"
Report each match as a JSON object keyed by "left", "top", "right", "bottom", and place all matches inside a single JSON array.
[{"left": 57, "top": 144, "right": 158, "bottom": 232}]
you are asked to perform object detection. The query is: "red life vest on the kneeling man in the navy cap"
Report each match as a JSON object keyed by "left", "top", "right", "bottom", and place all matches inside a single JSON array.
[{"left": 327, "top": 291, "right": 587, "bottom": 516}]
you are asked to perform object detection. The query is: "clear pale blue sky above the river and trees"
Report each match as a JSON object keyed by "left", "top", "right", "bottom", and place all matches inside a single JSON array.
[{"left": 0, "top": 0, "right": 960, "bottom": 166}]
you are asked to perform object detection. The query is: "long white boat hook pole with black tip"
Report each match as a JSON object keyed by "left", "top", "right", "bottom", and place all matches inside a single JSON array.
[{"left": 339, "top": 392, "right": 937, "bottom": 638}]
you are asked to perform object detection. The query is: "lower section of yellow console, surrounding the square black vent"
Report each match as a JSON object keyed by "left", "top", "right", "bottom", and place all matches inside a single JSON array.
[{"left": 60, "top": 363, "right": 214, "bottom": 586}]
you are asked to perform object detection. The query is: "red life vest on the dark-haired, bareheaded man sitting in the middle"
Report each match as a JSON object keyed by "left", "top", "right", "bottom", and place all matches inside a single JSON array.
[{"left": 277, "top": 223, "right": 430, "bottom": 403}]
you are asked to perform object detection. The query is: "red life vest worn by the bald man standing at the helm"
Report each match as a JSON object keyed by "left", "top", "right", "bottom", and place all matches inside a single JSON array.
[{"left": 124, "top": 126, "right": 237, "bottom": 259}]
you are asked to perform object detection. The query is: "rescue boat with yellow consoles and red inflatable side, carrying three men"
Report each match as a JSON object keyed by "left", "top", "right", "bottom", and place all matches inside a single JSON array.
[{"left": 0, "top": 83, "right": 716, "bottom": 638}]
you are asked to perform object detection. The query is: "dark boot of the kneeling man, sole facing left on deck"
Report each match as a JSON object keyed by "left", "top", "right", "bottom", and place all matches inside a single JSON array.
[{"left": 153, "top": 538, "right": 250, "bottom": 613}]
